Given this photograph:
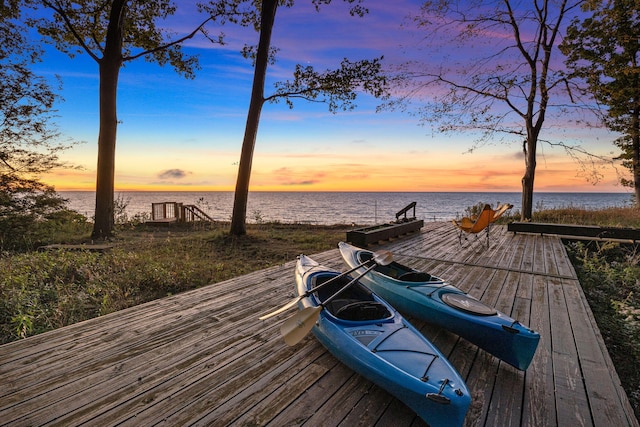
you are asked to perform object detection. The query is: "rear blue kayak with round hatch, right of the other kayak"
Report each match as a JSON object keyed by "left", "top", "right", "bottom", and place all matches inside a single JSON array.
[{"left": 338, "top": 242, "right": 540, "bottom": 370}]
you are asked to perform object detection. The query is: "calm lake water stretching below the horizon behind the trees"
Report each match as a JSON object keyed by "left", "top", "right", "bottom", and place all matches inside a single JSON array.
[{"left": 59, "top": 191, "right": 633, "bottom": 225}]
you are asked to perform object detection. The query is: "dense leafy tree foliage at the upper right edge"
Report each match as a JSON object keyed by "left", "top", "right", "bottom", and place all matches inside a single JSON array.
[{"left": 560, "top": 0, "right": 640, "bottom": 207}]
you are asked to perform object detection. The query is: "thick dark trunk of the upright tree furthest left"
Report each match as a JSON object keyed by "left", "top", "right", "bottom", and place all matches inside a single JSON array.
[{"left": 91, "top": 0, "right": 127, "bottom": 239}]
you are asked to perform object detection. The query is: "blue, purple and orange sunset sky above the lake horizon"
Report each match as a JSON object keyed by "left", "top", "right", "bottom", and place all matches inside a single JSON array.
[{"left": 36, "top": 0, "right": 626, "bottom": 192}]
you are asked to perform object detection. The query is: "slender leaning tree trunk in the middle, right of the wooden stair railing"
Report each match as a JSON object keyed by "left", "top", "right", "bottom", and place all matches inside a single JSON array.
[{"left": 230, "top": 0, "right": 278, "bottom": 236}]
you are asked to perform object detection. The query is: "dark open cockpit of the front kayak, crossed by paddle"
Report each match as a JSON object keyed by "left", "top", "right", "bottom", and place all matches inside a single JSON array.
[{"left": 311, "top": 274, "right": 393, "bottom": 321}]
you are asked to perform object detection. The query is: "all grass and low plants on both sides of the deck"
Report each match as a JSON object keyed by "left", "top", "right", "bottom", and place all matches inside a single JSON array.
[{"left": 0, "top": 207, "right": 640, "bottom": 418}]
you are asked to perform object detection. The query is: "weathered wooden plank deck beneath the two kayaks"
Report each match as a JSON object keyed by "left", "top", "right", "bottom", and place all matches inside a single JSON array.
[{"left": 0, "top": 222, "right": 638, "bottom": 427}]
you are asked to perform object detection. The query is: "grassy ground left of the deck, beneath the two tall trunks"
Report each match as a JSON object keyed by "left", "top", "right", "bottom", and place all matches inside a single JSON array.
[{"left": 0, "top": 224, "right": 345, "bottom": 344}]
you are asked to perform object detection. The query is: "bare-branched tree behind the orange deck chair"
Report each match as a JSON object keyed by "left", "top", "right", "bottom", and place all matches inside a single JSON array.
[{"left": 401, "top": 0, "right": 583, "bottom": 220}]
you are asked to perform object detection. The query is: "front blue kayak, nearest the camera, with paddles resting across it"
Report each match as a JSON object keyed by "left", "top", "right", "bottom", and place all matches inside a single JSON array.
[{"left": 295, "top": 255, "right": 471, "bottom": 427}]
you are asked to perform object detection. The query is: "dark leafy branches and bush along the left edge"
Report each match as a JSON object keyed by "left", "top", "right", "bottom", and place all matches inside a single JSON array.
[{"left": 0, "top": 5, "right": 84, "bottom": 251}]
